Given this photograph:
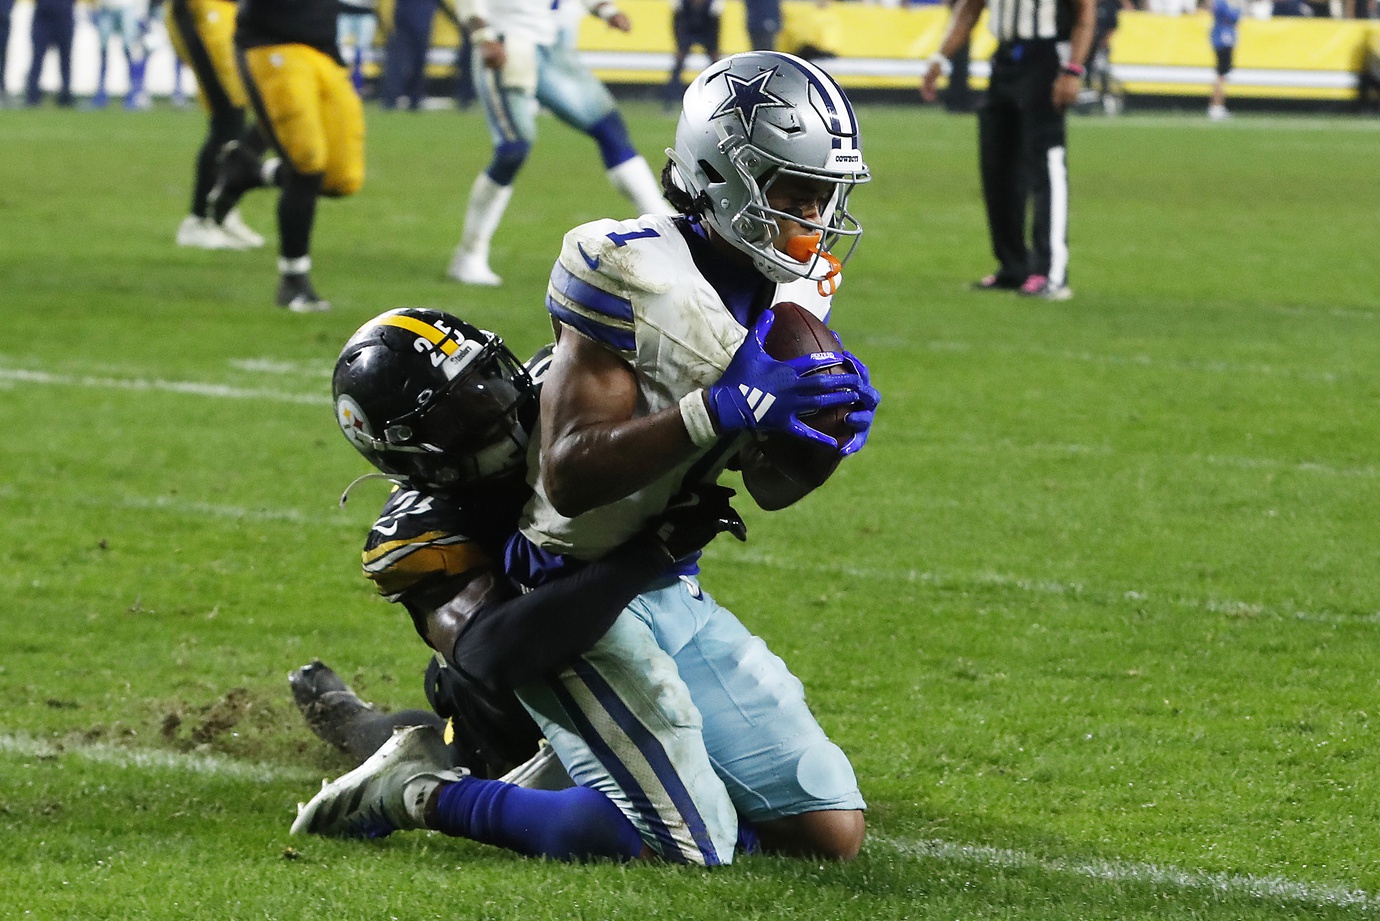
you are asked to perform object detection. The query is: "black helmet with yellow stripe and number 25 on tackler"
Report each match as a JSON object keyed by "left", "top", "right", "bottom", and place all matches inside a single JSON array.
[{"left": 331, "top": 307, "right": 537, "bottom": 490}]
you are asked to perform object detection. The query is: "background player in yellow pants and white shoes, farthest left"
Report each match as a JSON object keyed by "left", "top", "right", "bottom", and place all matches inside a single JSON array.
[{"left": 166, "top": 0, "right": 264, "bottom": 250}]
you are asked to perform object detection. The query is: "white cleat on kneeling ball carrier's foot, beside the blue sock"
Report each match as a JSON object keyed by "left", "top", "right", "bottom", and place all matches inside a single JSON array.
[{"left": 291, "top": 726, "right": 469, "bottom": 838}]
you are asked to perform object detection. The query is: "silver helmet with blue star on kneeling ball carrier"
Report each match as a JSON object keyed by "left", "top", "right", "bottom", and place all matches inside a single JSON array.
[{"left": 667, "top": 51, "right": 869, "bottom": 282}]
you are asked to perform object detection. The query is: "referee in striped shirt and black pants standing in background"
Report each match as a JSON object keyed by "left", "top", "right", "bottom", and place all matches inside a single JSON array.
[{"left": 920, "top": 0, "right": 1096, "bottom": 301}]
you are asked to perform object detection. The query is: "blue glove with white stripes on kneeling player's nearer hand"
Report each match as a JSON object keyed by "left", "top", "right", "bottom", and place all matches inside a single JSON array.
[{"left": 705, "top": 311, "right": 875, "bottom": 447}]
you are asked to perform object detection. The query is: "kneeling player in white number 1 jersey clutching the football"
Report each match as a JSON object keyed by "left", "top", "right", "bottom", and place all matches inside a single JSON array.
[{"left": 508, "top": 52, "right": 878, "bottom": 864}]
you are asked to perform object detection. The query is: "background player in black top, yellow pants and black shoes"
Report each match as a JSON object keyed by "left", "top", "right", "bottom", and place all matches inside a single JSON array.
[{"left": 235, "top": 0, "right": 364, "bottom": 312}]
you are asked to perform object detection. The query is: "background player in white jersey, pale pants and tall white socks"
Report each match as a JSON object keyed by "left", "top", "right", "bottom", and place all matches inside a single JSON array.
[{"left": 447, "top": 0, "right": 671, "bottom": 286}]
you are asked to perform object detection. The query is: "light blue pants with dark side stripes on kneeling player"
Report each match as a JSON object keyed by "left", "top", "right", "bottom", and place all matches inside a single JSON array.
[{"left": 519, "top": 580, "right": 864, "bottom": 866}]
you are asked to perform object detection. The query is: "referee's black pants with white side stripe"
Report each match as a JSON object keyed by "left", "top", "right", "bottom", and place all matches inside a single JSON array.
[{"left": 977, "top": 41, "right": 1068, "bottom": 284}]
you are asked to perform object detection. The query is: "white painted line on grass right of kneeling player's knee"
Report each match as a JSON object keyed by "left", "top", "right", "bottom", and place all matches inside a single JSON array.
[{"left": 872, "top": 837, "right": 1380, "bottom": 910}]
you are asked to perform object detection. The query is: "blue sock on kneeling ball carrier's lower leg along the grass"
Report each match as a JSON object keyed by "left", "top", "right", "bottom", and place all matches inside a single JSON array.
[{"left": 432, "top": 777, "right": 642, "bottom": 860}]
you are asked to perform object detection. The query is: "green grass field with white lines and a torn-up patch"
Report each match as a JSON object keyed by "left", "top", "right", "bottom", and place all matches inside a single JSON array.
[{"left": 0, "top": 100, "right": 1380, "bottom": 921}]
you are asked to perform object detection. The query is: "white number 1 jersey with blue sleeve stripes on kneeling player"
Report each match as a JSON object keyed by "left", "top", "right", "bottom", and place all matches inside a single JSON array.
[{"left": 522, "top": 214, "right": 829, "bottom": 559}]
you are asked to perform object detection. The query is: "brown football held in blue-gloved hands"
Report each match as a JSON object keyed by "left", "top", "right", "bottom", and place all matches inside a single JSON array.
[{"left": 758, "top": 301, "right": 853, "bottom": 489}]
